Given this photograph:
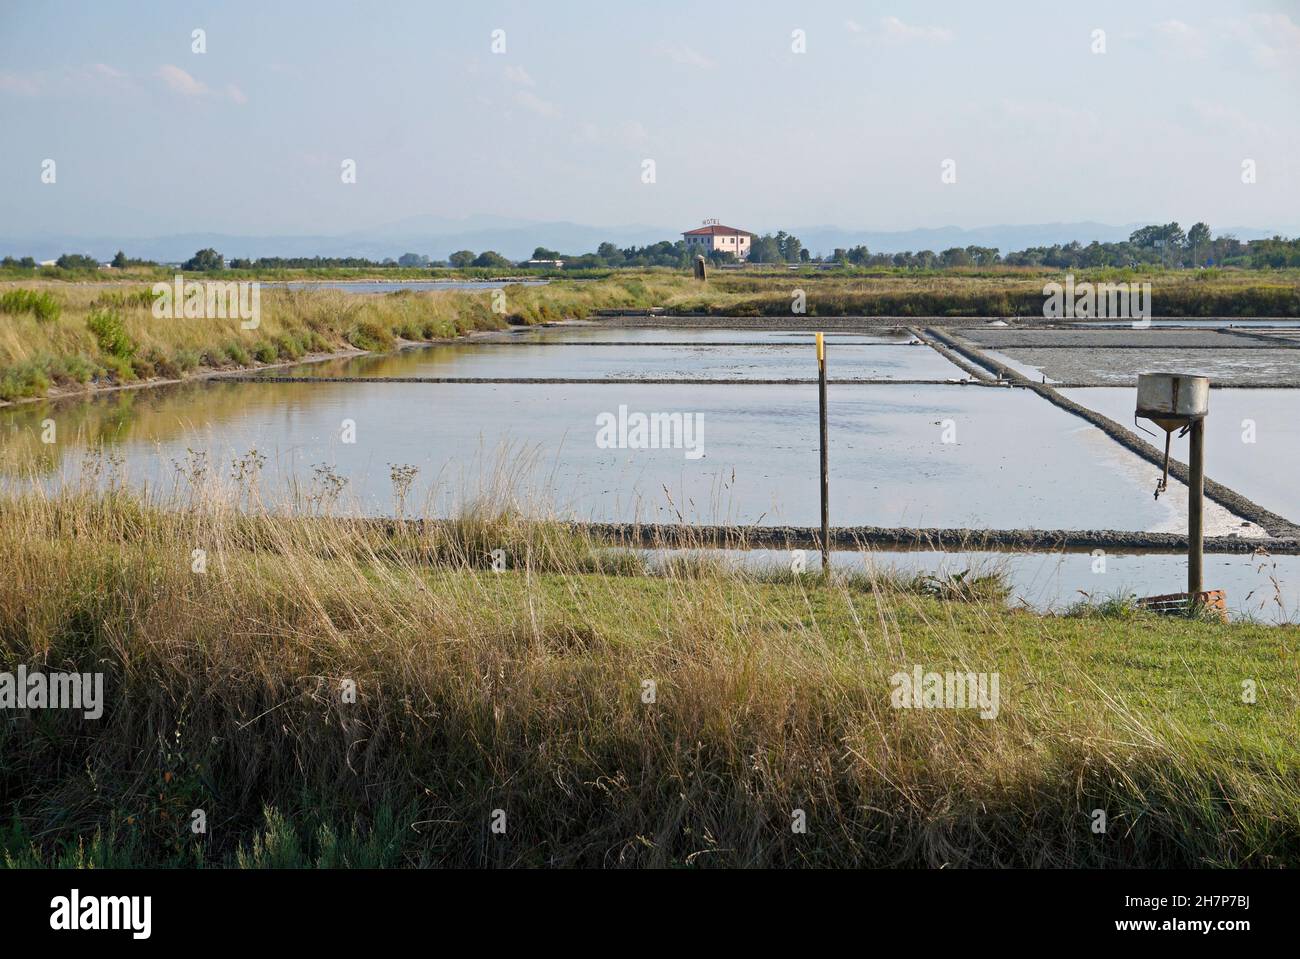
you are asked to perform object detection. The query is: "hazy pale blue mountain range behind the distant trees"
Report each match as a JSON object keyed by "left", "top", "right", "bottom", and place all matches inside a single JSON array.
[{"left": 0, "top": 216, "right": 1300, "bottom": 262}]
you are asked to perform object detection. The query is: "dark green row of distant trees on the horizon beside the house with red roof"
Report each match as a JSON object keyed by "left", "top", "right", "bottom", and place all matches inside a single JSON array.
[{"left": 10, "top": 222, "right": 1300, "bottom": 273}]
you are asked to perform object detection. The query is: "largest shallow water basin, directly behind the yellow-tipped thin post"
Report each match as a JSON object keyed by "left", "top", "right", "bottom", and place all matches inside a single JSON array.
[{"left": 0, "top": 381, "right": 1249, "bottom": 534}]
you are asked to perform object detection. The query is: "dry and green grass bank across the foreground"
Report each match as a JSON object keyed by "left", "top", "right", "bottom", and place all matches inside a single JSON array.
[{"left": 0, "top": 462, "right": 1300, "bottom": 865}]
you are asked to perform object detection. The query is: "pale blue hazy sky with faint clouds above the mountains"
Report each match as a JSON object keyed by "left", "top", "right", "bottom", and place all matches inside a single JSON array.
[{"left": 0, "top": 0, "right": 1300, "bottom": 237}]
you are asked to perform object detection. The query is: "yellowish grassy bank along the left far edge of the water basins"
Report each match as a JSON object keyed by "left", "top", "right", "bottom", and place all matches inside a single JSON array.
[{"left": 0, "top": 277, "right": 691, "bottom": 400}]
